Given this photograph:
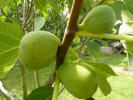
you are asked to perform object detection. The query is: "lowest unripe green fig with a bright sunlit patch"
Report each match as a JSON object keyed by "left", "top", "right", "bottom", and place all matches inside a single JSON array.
[{"left": 57, "top": 62, "right": 98, "bottom": 99}]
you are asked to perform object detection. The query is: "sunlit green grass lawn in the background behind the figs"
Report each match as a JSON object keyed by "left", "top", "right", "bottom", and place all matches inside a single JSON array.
[{"left": 0, "top": 54, "right": 133, "bottom": 100}]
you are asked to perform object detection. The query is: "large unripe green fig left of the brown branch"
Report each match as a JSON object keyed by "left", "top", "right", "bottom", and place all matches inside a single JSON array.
[{"left": 19, "top": 31, "right": 60, "bottom": 70}]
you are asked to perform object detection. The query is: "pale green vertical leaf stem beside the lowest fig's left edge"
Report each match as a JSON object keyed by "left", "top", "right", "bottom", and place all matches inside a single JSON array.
[{"left": 52, "top": 71, "right": 60, "bottom": 100}]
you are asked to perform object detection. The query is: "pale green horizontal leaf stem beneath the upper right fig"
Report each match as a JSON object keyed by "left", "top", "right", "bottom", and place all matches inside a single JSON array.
[{"left": 75, "top": 31, "right": 133, "bottom": 41}]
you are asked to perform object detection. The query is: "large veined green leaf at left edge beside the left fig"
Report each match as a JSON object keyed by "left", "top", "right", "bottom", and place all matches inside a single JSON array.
[{"left": 0, "top": 22, "right": 23, "bottom": 79}]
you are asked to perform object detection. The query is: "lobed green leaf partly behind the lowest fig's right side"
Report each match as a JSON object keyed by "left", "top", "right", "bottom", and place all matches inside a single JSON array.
[{"left": 84, "top": 62, "right": 116, "bottom": 96}]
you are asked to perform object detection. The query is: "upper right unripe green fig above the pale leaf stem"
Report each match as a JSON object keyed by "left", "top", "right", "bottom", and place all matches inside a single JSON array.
[{"left": 79, "top": 5, "right": 116, "bottom": 33}]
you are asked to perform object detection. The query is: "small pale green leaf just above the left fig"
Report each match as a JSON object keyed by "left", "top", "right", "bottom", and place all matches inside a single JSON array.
[{"left": 34, "top": 17, "right": 45, "bottom": 31}]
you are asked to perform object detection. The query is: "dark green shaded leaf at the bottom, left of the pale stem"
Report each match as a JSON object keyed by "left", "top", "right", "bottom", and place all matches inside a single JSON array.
[{"left": 26, "top": 86, "right": 53, "bottom": 100}]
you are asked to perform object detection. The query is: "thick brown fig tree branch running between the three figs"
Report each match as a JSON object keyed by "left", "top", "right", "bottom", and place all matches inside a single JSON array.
[{"left": 45, "top": 0, "right": 83, "bottom": 86}]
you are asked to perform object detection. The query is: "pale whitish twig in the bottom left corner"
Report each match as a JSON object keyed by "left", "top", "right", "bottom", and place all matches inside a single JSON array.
[{"left": 0, "top": 80, "right": 15, "bottom": 100}]
